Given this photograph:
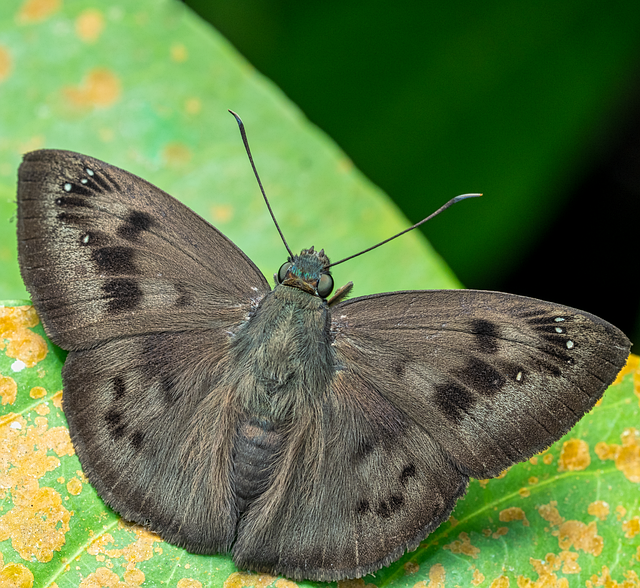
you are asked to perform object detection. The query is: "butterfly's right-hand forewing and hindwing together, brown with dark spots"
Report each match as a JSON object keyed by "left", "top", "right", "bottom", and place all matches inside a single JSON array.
[{"left": 233, "top": 290, "right": 629, "bottom": 581}]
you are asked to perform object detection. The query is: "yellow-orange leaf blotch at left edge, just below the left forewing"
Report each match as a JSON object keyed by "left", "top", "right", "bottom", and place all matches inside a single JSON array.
[{"left": 0, "top": 306, "right": 47, "bottom": 367}]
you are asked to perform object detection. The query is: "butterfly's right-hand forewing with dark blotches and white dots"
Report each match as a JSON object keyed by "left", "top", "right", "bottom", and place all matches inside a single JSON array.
[{"left": 332, "top": 290, "right": 630, "bottom": 478}]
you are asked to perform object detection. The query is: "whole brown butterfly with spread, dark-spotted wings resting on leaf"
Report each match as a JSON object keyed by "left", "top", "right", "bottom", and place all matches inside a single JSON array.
[{"left": 18, "top": 127, "right": 630, "bottom": 581}]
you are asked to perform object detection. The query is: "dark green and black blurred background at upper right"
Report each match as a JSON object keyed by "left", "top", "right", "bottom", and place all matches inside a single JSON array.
[{"left": 186, "top": 0, "right": 640, "bottom": 349}]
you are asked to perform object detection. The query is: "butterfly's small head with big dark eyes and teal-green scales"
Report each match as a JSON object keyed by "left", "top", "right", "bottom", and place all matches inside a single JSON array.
[{"left": 276, "top": 247, "right": 333, "bottom": 299}]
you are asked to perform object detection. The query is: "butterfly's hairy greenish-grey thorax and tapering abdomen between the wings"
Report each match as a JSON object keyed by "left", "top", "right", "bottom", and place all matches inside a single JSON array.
[{"left": 231, "top": 285, "right": 335, "bottom": 513}]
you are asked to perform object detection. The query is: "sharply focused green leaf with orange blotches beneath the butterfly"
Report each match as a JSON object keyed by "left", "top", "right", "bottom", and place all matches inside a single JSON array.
[{"left": 0, "top": 306, "right": 640, "bottom": 588}]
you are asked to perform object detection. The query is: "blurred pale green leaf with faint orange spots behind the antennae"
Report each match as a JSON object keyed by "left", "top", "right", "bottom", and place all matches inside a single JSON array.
[{"left": 0, "top": 0, "right": 460, "bottom": 306}]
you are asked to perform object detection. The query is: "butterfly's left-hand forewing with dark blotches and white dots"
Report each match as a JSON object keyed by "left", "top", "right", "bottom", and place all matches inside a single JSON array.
[{"left": 18, "top": 150, "right": 269, "bottom": 350}]
